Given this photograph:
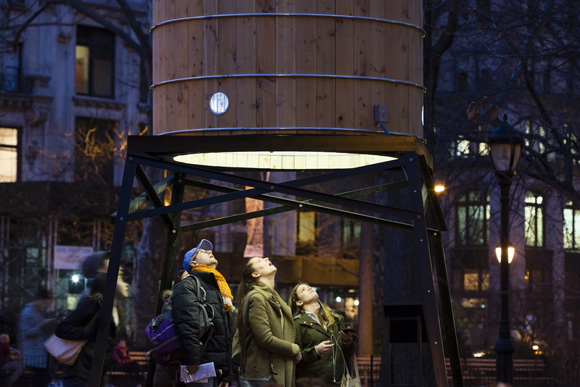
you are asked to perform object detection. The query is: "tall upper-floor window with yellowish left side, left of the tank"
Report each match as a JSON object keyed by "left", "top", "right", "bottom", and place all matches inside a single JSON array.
[{"left": 75, "top": 26, "right": 115, "bottom": 98}]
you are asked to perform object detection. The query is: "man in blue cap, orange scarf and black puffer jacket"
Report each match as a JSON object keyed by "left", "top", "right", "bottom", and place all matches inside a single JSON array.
[{"left": 172, "top": 239, "right": 233, "bottom": 387}]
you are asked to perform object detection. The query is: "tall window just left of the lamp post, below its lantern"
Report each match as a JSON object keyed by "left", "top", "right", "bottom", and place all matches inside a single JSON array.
[{"left": 456, "top": 190, "right": 490, "bottom": 246}]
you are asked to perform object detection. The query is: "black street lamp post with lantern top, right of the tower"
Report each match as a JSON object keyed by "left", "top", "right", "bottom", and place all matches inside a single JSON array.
[{"left": 487, "top": 117, "right": 522, "bottom": 385}]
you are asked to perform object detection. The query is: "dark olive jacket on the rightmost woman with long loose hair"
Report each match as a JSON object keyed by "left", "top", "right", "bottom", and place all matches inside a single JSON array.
[{"left": 294, "top": 310, "right": 355, "bottom": 386}]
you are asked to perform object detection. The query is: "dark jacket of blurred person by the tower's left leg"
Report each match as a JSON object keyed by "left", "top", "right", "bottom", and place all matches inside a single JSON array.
[{"left": 54, "top": 294, "right": 115, "bottom": 385}]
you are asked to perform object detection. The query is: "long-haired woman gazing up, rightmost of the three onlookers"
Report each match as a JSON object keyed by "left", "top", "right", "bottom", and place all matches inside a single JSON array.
[{"left": 290, "top": 283, "right": 356, "bottom": 386}]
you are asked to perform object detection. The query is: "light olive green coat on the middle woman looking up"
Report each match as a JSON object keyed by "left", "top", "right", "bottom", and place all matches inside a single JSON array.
[{"left": 232, "top": 283, "right": 300, "bottom": 387}]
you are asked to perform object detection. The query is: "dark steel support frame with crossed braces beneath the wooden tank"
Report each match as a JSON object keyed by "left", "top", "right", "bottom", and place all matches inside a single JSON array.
[{"left": 89, "top": 136, "right": 463, "bottom": 387}]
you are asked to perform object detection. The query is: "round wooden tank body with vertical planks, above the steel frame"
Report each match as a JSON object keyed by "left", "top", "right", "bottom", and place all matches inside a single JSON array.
[{"left": 152, "top": 0, "right": 424, "bottom": 136}]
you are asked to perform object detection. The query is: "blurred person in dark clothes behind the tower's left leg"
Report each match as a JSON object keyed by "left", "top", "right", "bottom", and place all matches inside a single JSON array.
[{"left": 54, "top": 272, "right": 129, "bottom": 387}]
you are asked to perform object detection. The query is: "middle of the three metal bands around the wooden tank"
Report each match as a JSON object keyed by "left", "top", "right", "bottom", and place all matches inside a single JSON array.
[{"left": 150, "top": 74, "right": 427, "bottom": 93}]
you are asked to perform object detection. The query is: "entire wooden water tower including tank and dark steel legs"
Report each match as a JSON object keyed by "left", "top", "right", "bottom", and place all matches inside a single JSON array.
[{"left": 93, "top": 0, "right": 462, "bottom": 386}]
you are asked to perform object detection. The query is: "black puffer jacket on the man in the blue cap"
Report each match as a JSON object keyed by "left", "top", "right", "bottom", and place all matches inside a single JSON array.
[{"left": 173, "top": 271, "right": 232, "bottom": 383}]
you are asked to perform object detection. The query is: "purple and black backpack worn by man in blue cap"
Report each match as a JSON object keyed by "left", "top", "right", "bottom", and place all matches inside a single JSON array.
[{"left": 145, "top": 275, "right": 213, "bottom": 365}]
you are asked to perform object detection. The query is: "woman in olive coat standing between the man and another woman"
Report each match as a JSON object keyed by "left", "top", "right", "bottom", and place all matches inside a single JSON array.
[{"left": 233, "top": 258, "right": 301, "bottom": 387}]
